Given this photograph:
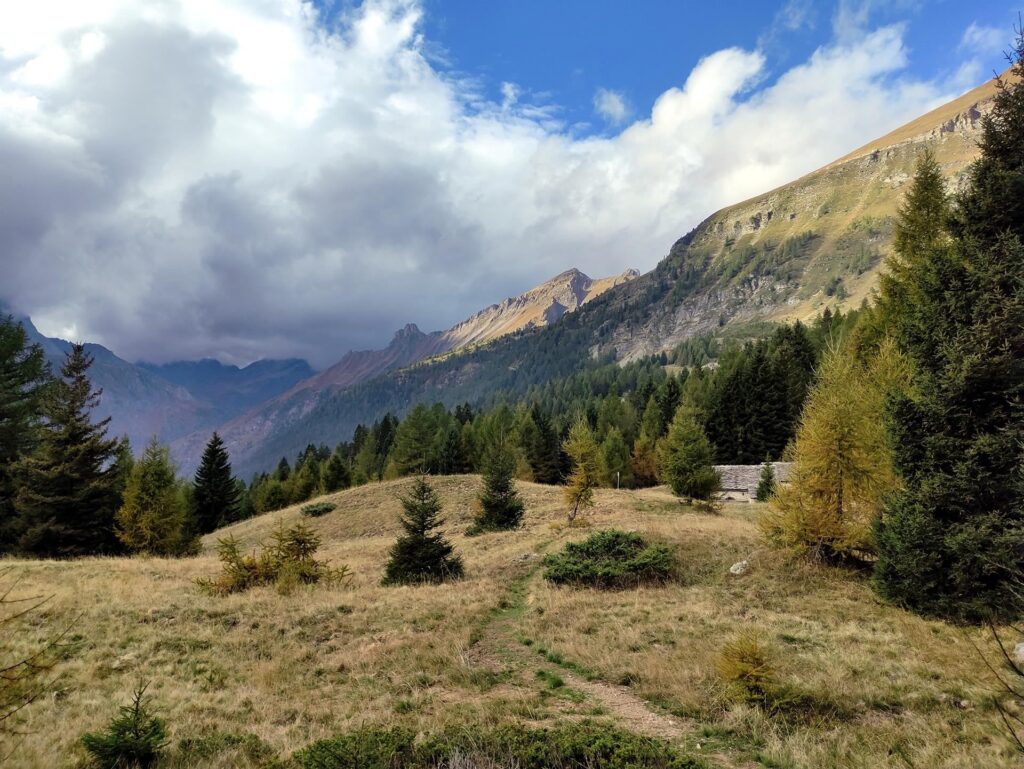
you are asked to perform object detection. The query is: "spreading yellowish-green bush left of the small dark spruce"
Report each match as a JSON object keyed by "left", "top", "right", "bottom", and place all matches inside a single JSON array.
[{"left": 198, "top": 523, "right": 351, "bottom": 595}]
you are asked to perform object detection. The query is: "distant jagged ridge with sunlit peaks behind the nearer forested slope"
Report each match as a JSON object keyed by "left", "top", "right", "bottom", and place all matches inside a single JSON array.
[{"left": 173, "top": 269, "right": 639, "bottom": 469}]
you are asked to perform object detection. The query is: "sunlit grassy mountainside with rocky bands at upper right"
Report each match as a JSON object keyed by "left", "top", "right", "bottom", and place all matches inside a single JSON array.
[{"left": 595, "top": 72, "right": 995, "bottom": 358}]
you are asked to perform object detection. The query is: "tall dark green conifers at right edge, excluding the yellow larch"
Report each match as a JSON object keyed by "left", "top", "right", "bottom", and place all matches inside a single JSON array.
[{"left": 876, "top": 35, "right": 1024, "bottom": 622}]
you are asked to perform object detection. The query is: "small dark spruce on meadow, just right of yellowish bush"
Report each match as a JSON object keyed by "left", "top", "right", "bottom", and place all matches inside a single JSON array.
[{"left": 382, "top": 477, "right": 463, "bottom": 585}]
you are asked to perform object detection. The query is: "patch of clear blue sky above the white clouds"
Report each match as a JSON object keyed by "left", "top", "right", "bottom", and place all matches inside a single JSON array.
[{"left": 407, "top": 0, "right": 1024, "bottom": 132}]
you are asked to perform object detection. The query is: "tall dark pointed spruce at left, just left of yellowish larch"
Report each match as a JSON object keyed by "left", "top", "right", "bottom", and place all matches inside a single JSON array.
[{"left": 14, "top": 344, "right": 120, "bottom": 557}]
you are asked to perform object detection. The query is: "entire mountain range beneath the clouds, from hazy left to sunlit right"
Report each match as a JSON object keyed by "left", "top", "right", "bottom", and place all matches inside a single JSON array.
[{"left": 14, "top": 72, "right": 995, "bottom": 481}]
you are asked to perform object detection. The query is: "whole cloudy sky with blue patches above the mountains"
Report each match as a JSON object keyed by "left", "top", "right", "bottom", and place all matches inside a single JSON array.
[{"left": 0, "top": 0, "right": 1019, "bottom": 367}]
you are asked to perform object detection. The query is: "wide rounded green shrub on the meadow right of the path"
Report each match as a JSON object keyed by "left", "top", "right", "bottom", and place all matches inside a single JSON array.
[{"left": 544, "top": 529, "right": 676, "bottom": 589}]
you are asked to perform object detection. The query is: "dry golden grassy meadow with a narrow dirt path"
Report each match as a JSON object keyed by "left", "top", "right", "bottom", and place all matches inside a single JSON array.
[{"left": 0, "top": 476, "right": 1017, "bottom": 769}]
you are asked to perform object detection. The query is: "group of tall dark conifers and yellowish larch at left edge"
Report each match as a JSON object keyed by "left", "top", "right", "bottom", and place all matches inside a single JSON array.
[{"left": 0, "top": 339, "right": 246, "bottom": 558}]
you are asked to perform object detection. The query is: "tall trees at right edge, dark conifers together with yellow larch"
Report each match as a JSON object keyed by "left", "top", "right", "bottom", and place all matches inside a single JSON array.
[{"left": 762, "top": 45, "right": 1024, "bottom": 623}]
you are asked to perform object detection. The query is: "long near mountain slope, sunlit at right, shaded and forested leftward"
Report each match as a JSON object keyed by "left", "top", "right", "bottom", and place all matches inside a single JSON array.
[{"left": 218, "top": 75, "right": 995, "bottom": 479}]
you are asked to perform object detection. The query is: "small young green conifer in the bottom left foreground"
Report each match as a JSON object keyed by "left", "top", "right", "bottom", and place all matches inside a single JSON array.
[{"left": 82, "top": 685, "right": 167, "bottom": 769}]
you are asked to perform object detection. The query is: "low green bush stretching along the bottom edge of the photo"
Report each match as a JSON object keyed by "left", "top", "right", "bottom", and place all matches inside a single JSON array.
[{"left": 295, "top": 721, "right": 703, "bottom": 769}]
